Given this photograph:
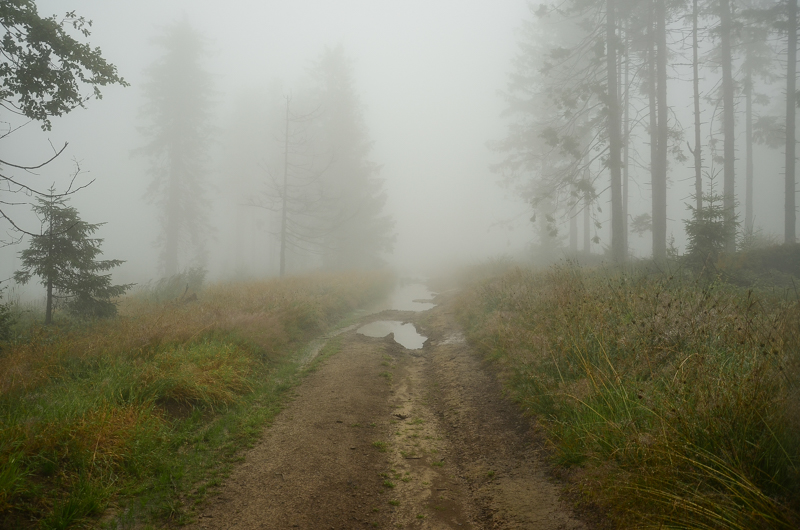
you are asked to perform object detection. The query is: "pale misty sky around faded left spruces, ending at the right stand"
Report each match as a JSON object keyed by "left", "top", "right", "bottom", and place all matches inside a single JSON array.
[{"left": 2, "top": 0, "right": 530, "bottom": 281}]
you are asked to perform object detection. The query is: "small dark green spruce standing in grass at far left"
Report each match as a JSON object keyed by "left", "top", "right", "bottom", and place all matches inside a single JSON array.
[{"left": 14, "top": 189, "right": 130, "bottom": 324}]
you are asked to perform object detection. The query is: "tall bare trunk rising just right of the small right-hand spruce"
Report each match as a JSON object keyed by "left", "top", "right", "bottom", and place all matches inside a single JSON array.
[{"left": 719, "top": 0, "right": 736, "bottom": 252}]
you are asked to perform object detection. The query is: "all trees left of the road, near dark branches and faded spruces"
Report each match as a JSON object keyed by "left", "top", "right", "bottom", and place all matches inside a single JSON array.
[{"left": 0, "top": 4, "right": 394, "bottom": 323}]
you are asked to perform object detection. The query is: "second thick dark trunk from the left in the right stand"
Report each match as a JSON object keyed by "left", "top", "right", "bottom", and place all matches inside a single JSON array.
[{"left": 653, "top": 0, "right": 669, "bottom": 260}]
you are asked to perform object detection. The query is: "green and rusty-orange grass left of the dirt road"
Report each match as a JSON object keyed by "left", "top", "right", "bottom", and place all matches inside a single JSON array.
[{"left": 0, "top": 274, "right": 391, "bottom": 529}]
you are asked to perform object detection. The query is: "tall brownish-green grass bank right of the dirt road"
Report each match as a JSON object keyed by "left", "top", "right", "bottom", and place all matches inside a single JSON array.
[{"left": 457, "top": 265, "right": 800, "bottom": 529}]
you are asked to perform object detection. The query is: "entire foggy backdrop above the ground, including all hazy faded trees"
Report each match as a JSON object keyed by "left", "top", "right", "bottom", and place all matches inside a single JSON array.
[{"left": 0, "top": 0, "right": 797, "bottom": 302}]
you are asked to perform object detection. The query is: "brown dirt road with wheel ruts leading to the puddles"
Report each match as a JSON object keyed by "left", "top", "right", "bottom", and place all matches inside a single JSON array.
[{"left": 193, "top": 288, "right": 586, "bottom": 530}]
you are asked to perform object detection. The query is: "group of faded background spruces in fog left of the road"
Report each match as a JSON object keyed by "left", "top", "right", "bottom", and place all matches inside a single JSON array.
[{"left": 138, "top": 21, "right": 394, "bottom": 276}]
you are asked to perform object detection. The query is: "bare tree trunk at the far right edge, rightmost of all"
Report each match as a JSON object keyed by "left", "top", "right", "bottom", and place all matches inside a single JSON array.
[{"left": 784, "top": 0, "right": 797, "bottom": 244}]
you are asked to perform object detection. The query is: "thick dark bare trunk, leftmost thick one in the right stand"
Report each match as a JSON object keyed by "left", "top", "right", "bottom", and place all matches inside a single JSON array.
[{"left": 606, "top": 0, "right": 627, "bottom": 263}]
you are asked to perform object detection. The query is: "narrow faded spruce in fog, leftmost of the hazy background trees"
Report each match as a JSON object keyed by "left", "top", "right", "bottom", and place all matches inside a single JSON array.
[{"left": 138, "top": 20, "right": 213, "bottom": 276}]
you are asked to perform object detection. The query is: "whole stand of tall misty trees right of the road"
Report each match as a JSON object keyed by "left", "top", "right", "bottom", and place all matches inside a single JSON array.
[{"left": 493, "top": 0, "right": 798, "bottom": 261}]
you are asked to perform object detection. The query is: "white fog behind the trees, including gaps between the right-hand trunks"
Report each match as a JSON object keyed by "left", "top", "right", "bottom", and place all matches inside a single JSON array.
[{"left": 0, "top": 0, "right": 782, "bottom": 292}]
